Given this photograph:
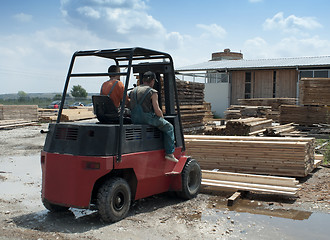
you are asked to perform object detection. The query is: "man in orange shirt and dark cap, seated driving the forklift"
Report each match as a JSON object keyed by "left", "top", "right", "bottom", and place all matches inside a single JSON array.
[{"left": 100, "top": 65, "right": 129, "bottom": 108}]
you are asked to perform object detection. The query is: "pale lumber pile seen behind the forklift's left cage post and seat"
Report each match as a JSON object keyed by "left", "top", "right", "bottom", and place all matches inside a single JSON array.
[{"left": 39, "top": 107, "right": 95, "bottom": 122}]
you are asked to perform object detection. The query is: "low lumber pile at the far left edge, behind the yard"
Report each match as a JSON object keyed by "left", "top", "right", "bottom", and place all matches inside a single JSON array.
[{"left": 0, "top": 105, "right": 38, "bottom": 121}]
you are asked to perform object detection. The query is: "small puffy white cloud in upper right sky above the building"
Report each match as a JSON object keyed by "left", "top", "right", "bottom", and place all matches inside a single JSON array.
[{"left": 263, "top": 12, "right": 322, "bottom": 33}]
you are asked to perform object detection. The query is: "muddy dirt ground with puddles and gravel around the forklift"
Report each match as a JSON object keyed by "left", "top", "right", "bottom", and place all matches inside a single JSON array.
[{"left": 0, "top": 124, "right": 330, "bottom": 240}]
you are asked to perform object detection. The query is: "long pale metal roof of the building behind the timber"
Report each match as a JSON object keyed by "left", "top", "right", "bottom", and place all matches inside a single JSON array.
[{"left": 176, "top": 56, "right": 330, "bottom": 72}]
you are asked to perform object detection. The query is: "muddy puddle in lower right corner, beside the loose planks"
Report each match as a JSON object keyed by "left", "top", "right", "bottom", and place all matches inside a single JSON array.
[{"left": 205, "top": 199, "right": 330, "bottom": 240}]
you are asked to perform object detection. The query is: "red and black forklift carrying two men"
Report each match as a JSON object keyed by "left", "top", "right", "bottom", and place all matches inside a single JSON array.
[{"left": 41, "top": 47, "right": 201, "bottom": 222}]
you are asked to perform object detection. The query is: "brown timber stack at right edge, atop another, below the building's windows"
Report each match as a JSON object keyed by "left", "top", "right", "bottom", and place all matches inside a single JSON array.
[{"left": 299, "top": 78, "right": 330, "bottom": 106}]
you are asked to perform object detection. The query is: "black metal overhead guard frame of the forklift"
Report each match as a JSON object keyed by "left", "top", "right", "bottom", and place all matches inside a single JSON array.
[{"left": 56, "top": 47, "right": 185, "bottom": 162}]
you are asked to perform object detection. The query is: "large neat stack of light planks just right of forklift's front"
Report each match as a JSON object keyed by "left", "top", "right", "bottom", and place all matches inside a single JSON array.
[{"left": 185, "top": 135, "right": 315, "bottom": 177}]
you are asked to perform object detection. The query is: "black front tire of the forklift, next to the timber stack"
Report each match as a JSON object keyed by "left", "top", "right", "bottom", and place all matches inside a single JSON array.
[{"left": 178, "top": 159, "right": 202, "bottom": 199}]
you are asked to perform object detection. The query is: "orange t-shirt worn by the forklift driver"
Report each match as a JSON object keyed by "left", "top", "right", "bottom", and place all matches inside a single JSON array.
[{"left": 100, "top": 80, "right": 129, "bottom": 107}]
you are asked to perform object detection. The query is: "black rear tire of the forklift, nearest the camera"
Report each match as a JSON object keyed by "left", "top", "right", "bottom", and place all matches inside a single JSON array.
[{"left": 97, "top": 178, "right": 131, "bottom": 222}]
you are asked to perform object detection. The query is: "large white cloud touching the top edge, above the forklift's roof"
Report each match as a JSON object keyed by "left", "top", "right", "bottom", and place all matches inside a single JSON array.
[{"left": 61, "top": 0, "right": 166, "bottom": 42}]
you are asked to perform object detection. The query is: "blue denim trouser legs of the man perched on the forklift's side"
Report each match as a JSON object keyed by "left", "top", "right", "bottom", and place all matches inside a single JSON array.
[{"left": 131, "top": 106, "right": 175, "bottom": 154}]
